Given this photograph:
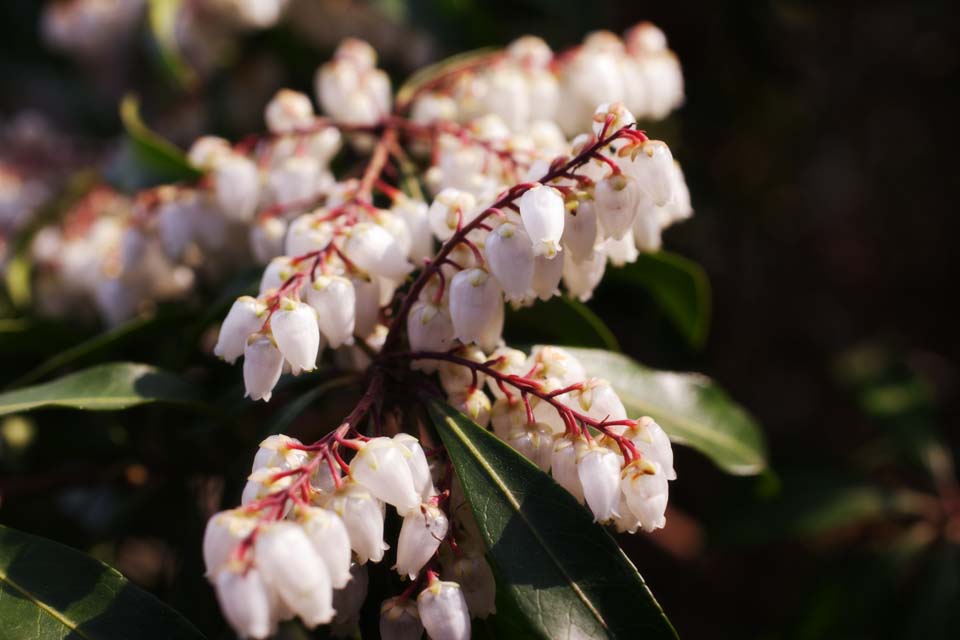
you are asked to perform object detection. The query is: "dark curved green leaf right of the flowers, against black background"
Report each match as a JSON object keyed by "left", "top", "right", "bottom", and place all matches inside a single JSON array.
[{"left": 610, "top": 251, "right": 710, "bottom": 349}]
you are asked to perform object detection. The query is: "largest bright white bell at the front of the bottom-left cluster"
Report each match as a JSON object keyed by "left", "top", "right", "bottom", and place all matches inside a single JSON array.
[{"left": 254, "top": 521, "right": 333, "bottom": 628}]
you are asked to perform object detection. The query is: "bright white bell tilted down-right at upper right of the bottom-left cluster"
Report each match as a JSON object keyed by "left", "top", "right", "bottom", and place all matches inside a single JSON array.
[{"left": 350, "top": 438, "right": 420, "bottom": 516}]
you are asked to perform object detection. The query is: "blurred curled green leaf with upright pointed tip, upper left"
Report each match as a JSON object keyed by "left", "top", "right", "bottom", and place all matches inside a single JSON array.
[{"left": 108, "top": 94, "right": 203, "bottom": 191}]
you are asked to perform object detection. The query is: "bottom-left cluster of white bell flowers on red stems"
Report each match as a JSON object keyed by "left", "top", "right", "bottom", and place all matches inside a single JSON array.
[{"left": 203, "top": 429, "right": 494, "bottom": 639}]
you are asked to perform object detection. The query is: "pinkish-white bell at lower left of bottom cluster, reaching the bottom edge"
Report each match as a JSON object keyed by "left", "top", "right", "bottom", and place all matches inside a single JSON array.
[{"left": 214, "top": 567, "right": 277, "bottom": 640}]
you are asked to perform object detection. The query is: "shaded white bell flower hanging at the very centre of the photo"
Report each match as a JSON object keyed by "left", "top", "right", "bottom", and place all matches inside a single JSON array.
[{"left": 450, "top": 268, "right": 503, "bottom": 351}]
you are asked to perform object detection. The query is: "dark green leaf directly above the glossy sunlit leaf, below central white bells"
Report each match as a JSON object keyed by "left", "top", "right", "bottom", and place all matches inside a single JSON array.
[{"left": 505, "top": 296, "right": 620, "bottom": 351}]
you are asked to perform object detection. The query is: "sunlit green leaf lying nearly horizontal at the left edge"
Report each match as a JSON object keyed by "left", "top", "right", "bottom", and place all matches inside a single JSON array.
[{"left": 0, "top": 362, "right": 202, "bottom": 415}]
